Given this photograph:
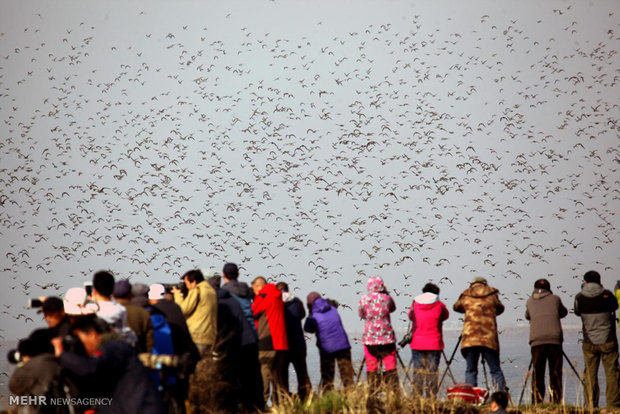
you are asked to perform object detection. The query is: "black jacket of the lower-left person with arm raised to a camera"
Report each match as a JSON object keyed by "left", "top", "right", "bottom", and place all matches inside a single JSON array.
[{"left": 59, "top": 341, "right": 167, "bottom": 414}]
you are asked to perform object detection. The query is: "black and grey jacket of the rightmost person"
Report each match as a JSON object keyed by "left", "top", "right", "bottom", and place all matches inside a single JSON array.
[{"left": 575, "top": 283, "right": 618, "bottom": 345}]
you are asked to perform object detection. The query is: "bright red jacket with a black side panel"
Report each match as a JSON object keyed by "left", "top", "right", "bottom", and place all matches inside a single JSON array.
[{"left": 252, "top": 283, "right": 288, "bottom": 351}]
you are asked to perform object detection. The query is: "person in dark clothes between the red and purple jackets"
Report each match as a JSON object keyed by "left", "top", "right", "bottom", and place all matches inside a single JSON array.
[{"left": 276, "top": 282, "right": 312, "bottom": 401}]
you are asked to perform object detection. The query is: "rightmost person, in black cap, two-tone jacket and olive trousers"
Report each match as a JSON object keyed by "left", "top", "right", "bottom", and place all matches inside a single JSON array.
[{"left": 574, "top": 270, "right": 620, "bottom": 409}]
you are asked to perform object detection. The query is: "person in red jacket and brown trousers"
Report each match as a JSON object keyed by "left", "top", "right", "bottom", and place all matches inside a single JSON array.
[{"left": 252, "top": 276, "right": 288, "bottom": 402}]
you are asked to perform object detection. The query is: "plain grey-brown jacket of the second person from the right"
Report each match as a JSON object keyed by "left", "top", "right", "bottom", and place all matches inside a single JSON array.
[{"left": 525, "top": 289, "right": 568, "bottom": 346}]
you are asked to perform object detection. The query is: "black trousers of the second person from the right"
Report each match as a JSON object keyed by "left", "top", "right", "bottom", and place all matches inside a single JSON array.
[{"left": 532, "top": 344, "right": 563, "bottom": 404}]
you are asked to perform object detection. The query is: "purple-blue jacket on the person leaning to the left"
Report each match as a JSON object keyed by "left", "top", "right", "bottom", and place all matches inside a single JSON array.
[{"left": 304, "top": 298, "right": 351, "bottom": 354}]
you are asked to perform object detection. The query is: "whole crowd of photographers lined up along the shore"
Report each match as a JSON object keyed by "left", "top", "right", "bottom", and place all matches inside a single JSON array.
[{"left": 10, "top": 263, "right": 620, "bottom": 413}]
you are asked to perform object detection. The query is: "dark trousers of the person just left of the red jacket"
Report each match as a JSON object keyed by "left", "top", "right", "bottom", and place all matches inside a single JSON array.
[{"left": 238, "top": 343, "right": 265, "bottom": 411}]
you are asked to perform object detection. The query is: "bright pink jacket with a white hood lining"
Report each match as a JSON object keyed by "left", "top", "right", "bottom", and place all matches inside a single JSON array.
[{"left": 409, "top": 292, "right": 450, "bottom": 351}]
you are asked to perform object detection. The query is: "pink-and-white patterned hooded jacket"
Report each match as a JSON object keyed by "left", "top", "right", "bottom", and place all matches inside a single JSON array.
[{"left": 358, "top": 277, "right": 396, "bottom": 345}]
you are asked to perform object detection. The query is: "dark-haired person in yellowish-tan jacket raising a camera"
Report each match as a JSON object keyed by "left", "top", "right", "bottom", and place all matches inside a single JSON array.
[{"left": 172, "top": 270, "right": 217, "bottom": 356}]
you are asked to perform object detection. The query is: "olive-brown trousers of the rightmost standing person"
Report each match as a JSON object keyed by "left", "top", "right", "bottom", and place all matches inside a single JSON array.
[{"left": 581, "top": 342, "right": 620, "bottom": 408}]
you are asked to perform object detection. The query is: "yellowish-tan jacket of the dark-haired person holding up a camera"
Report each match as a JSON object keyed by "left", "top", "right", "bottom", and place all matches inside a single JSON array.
[{"left": 174, "top": 280, "right": 217, "bottom": 345}]
